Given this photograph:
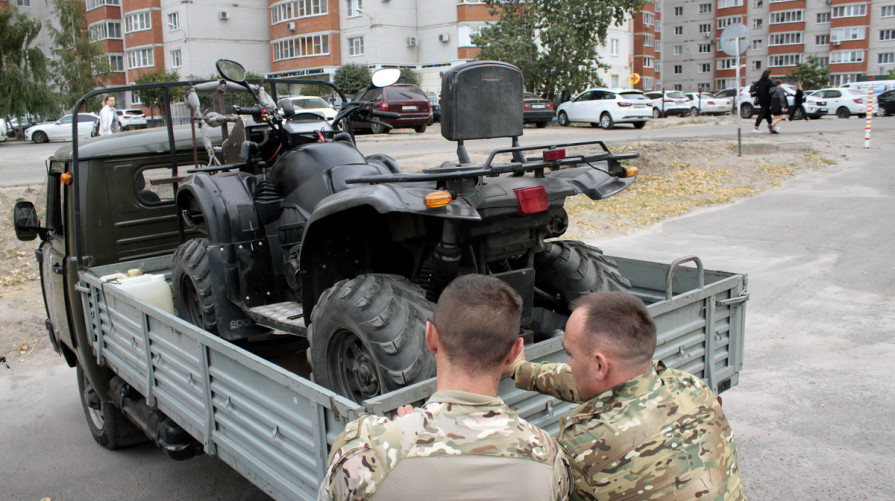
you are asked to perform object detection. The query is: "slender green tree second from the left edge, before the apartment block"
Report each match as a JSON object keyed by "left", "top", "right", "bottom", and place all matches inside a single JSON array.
[{"left": 50, "top": 0, "right": 111, "bottom": 111}]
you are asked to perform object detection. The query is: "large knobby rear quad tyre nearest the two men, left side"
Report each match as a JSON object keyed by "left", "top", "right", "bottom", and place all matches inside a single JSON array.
[{"left": 308, "top": 274, "right": 435, "bottom": 402}]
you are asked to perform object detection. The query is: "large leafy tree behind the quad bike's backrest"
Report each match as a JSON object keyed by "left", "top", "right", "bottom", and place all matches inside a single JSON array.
[{"left": 472, "top": 0, "right": 645, "bottom": 98}]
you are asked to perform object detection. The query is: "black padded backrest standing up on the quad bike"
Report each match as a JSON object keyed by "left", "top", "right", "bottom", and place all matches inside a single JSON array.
[{"left": 441, "top": 61, "right": 524, "bottom": 141}]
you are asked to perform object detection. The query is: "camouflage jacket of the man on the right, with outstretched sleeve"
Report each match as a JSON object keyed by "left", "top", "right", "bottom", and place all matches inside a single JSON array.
[{"left": 514, "top": 362, "right": 746, "bottom": 501}]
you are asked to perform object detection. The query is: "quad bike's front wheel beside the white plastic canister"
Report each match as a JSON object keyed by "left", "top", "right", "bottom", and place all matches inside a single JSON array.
[{"left": 171, "top": 238, "right": 217, "bottom": 333}]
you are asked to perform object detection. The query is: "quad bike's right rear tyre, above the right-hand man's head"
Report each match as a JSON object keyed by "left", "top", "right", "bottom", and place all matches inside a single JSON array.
[{"left": 535, "top": 240, "right": 631, "bottom": 314}]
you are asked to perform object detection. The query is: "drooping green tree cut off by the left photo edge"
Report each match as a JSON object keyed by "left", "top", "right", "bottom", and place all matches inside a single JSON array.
[{"left": 0, "top": 7, "right": 59, "bottom": 132}]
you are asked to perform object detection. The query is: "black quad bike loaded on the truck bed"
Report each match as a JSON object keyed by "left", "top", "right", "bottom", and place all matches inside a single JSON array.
[{"left": 173, "top": 61, "right": 637, "bottom": 401}]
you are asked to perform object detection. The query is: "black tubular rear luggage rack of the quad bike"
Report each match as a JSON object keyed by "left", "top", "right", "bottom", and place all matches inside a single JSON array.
[{"left": 345, "top": 141, "right": 640, "bottom": 184}]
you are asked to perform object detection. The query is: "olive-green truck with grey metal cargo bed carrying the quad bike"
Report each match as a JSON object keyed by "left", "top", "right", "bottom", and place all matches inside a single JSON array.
[{"left": 14, "top": 64, "right": 748, "bottom": 499}]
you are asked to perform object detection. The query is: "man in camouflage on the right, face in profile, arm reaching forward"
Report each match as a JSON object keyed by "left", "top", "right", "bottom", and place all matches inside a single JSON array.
[{"left": 505, "top": 292, "right": 745, "bottom": 501}]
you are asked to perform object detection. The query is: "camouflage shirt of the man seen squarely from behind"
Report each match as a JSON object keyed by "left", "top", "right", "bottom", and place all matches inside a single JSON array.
[{"left": 318, "top": 391, "right": 570, "bottom": 500}]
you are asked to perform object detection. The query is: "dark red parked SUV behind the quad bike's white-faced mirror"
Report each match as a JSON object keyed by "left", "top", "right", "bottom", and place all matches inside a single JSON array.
[{"left": 351, "top": 84, "right": 431, "bottom": 134}]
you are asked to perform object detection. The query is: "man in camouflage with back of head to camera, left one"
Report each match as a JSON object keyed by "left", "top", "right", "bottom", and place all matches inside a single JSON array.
[{"left": 318, "top": 275, "right": 570, "bottom": 500}]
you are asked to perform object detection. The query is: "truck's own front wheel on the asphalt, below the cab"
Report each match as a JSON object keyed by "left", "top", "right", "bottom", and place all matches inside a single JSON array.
[{"left": 77, "top": 364, "right": 149, "bottom": 449}]
